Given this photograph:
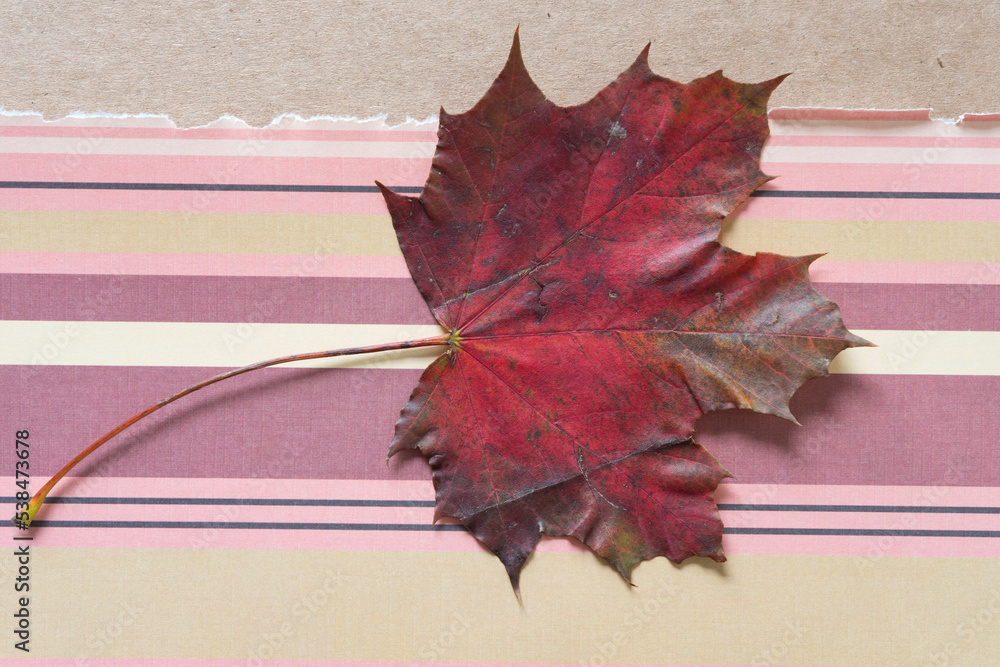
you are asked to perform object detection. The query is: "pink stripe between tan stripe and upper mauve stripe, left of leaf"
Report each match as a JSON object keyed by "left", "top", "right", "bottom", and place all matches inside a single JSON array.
[{"left": 0, "top": 253, "right": 410, "bottom": 278}]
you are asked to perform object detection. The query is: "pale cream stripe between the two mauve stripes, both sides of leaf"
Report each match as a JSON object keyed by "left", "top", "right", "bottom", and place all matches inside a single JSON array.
[{"left": 0, "top": 320, "right": 1000, "bottom": 375}]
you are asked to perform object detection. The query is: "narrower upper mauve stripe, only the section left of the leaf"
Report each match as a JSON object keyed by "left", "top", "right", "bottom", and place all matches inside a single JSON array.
[{"left": 0, "top": 274, "right": 434, "bottom": 324}]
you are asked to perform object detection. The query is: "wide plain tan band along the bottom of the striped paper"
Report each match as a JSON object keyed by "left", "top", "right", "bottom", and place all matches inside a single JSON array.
[{"left": 0, "top": 548, "right": 1000, "bottom": 665}]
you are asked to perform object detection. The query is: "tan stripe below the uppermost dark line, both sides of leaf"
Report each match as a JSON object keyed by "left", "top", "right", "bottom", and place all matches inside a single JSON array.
[{"left": 0, "top": 211, "right": 1000, "bottom": 262}]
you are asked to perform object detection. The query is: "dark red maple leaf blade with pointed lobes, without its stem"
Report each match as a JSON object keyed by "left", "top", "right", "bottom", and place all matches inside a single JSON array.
[{"left": 379, "top": 33, "right": 868, "bottom": 592}]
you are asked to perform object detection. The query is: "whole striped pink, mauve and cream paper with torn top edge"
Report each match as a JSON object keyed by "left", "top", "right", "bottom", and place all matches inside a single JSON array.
[{"left": 0, "top": 110, "right": 1000, "bottom": 666}]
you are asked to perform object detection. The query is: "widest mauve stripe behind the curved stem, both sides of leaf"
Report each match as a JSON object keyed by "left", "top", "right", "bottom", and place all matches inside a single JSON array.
[{"left": 7, "top": 366, "right": 1000, "bottom": 486}]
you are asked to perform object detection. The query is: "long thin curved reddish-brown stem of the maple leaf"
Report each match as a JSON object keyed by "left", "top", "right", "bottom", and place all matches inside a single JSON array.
[{"left": 13, "top": 335, "right": 451, "bottom": 529}]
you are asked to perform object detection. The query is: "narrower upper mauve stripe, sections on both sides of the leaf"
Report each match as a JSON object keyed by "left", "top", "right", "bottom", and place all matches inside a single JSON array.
[{"left": 0, "top": 274, "right": 1000, "bottom": 331}]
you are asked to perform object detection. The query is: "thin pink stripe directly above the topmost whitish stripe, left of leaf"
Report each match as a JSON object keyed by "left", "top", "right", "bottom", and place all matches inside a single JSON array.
[{"left": 0, "top": 123, "right": 437, "bottom": 143}]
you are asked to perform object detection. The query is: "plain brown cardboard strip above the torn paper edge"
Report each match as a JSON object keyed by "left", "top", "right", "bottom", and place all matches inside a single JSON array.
[{"left": 0, "top": 0, "right": 1000, "bottom": 127}]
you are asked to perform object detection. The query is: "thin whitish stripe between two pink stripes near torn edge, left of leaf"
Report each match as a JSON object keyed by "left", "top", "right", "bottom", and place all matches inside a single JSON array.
[{"left": 0, "top": 133, "right": 434, "bottom": 160}]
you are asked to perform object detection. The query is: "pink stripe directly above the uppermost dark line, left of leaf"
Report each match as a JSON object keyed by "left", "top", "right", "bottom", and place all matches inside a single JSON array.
[{"left": 0, "top": 155, "right": 431, "bottom": 186}]
